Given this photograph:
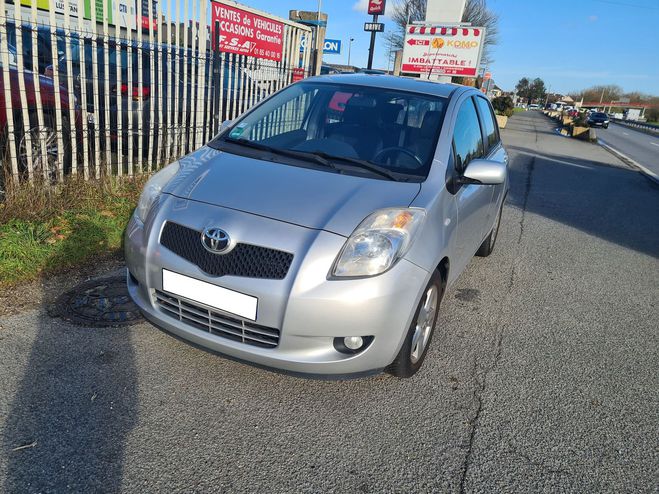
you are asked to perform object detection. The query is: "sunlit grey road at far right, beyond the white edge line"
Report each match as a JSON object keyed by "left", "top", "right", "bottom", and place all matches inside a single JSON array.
[{"left": 596, "top": 123, "right": 659, "bottom": 177}]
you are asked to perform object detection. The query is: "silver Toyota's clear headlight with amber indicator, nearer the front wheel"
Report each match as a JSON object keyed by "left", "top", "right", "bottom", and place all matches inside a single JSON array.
[{"left": 332, "top": 209, "right": 426, "bottom": 277}]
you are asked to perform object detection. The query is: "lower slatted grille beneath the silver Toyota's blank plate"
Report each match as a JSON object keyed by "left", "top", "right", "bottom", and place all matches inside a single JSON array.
[{"left": 155, "top": 290, "right": 279, "bottom": 348}]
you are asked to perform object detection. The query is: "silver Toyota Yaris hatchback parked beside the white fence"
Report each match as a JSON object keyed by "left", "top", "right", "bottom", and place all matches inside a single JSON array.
[{"left": 125, "top": 75, "right": 508, "bottom": 377}]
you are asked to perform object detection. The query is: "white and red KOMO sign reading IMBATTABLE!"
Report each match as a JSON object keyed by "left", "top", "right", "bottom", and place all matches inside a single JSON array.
[{"left": 401, "top": 25, "right": 485, "bottom": 77}]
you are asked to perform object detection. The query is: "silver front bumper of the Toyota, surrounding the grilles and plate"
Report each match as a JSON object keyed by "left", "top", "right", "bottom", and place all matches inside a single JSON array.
[{"left": 125, "top": 196, "right": 430, "bottom": 375}]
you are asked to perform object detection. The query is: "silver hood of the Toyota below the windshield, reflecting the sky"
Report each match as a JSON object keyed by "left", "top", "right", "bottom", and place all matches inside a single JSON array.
[{"left": 164, "top": 146, "right": 421, "bottom": 236}]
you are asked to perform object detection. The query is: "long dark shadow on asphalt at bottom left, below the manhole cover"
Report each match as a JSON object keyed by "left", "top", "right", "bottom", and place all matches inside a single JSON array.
[{"left": 0, "top": 233, "right": 138, "bottom": 492}]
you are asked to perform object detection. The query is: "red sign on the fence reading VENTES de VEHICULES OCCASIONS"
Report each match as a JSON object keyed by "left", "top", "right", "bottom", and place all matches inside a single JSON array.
[{"left": 211, "top": 1, "right": 284, "bottom": 62}]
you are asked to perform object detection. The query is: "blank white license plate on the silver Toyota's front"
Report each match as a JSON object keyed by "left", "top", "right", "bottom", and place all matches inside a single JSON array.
[{"left": 162, "top": 269, "right": 258, "bottom": 321}]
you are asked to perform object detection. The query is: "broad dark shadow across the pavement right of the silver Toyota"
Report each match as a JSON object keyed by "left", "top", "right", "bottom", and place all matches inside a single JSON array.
[{"left": 507, "top": 146, "right": 659, "bottom": 257}]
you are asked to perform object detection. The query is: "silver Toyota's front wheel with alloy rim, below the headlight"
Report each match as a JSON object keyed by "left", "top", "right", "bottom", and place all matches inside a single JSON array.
[{"left": 386, "top": 271, "right": 444, "bottom": 378}]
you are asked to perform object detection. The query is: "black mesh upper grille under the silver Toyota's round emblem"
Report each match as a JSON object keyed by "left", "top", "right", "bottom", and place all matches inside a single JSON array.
[{"left": 160, "top": 221, "right": 293, "bottom": 280}]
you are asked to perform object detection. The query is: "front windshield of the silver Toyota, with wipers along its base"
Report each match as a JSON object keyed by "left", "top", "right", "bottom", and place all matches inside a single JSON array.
[{"left": 211, "top": 81, "right": 446, "bottom": 180}]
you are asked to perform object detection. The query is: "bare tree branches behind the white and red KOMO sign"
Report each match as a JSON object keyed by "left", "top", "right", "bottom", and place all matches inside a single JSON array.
[{"left": 386, "top": 0, "right": 499, "bottom": 66}]
